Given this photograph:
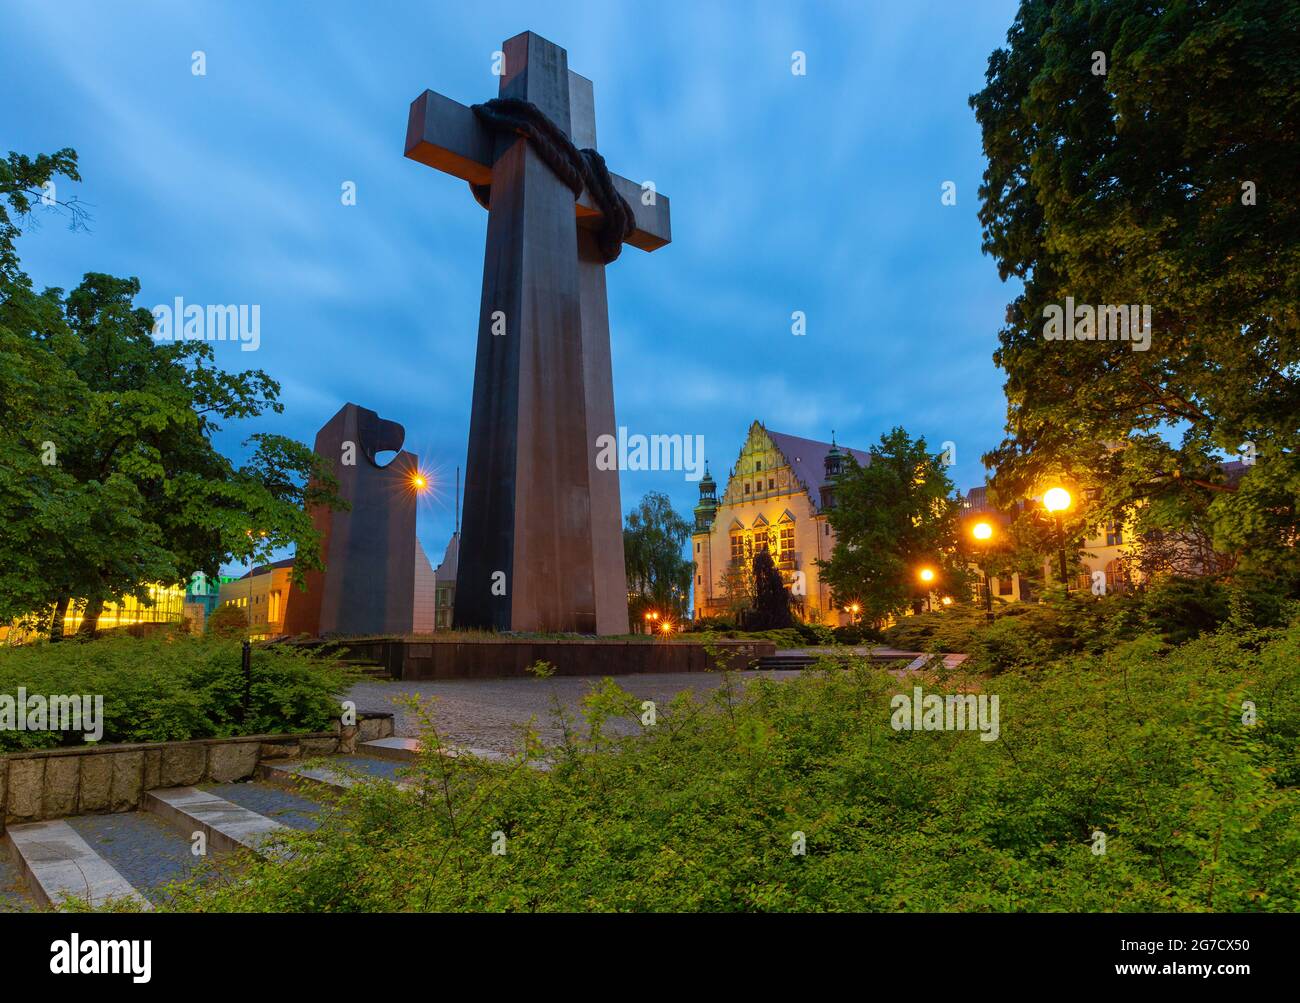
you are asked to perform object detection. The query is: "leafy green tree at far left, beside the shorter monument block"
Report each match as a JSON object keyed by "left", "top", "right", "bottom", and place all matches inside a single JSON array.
[{"left": 0, "top": 151, "right": 342, "bottom": 639}]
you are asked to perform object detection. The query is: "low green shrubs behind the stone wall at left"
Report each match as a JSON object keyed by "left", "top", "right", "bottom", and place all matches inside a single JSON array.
[{"left": 0, "top": 634, "right": 356, "bottom": 751}]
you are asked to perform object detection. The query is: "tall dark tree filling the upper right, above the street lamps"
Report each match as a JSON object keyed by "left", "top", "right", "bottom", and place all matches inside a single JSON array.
[{"left": 971, "top": 0, "right": 1300, "bottom": 587}]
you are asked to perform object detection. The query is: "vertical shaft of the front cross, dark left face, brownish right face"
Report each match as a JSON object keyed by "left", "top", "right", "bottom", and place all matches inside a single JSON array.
[{"left": 455, "top": 31, "right": 598, "bottom": 633}]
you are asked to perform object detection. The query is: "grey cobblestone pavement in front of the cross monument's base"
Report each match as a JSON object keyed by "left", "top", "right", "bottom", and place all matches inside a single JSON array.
[{"left": 348, "top": 669, "right": 800, "bottom": 752}]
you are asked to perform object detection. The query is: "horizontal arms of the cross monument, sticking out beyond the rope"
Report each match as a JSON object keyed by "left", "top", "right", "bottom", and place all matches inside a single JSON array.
[{"left": 406, "top": 91, "right": 672, "bottom": 251}]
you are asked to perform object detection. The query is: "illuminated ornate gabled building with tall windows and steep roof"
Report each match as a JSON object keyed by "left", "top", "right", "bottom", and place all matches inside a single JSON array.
[{"left": 690, "top": 421, "right": 871, "bottom": 626}]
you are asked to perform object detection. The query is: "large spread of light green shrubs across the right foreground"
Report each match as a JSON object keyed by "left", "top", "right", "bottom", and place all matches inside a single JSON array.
[{"left": 168, "top": 617, "right": 1300, "bottom": 912}]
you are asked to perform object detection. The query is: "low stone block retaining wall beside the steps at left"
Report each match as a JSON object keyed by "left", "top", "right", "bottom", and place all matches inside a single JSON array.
[{"left": 0, "top": 712, "right": 393, "bottom": 833}]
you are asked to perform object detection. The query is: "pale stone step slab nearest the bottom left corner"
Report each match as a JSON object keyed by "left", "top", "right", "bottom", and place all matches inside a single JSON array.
[{"left": 5, "top": 819, "right": 152, "bottom": 909}]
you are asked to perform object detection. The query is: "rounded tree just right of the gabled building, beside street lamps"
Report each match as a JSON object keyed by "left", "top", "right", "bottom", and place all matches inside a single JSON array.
[{"left": 819, "top": 429, "right": 971, "bottom": 622}]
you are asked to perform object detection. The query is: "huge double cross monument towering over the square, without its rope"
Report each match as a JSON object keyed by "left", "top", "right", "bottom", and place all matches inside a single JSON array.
[{"left": 406, "top": 31, "right": 671, "bottom": 634}]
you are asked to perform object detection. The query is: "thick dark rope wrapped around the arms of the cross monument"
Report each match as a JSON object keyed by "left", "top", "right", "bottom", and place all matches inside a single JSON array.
[{"left": 469, "top": 97, "right": 636, "bottom": 264}]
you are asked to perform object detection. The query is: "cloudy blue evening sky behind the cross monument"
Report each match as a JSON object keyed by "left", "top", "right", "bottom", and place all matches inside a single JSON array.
[{"left": 0, "top": 0, "right": 1017, "bottom": 564}]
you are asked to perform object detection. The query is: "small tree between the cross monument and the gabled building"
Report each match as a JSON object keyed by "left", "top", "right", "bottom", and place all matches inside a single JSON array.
[{"left": 623, "top": 491, "right": 696, "bottom": 618}]
